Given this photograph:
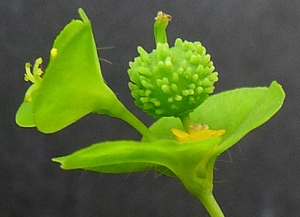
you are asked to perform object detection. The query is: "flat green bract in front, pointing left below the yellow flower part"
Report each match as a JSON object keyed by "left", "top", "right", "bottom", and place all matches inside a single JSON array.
[{"left": 53, "top": 137, "right": 220, "bottom": 178}]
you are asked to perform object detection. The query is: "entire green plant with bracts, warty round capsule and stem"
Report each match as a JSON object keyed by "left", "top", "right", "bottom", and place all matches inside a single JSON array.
[{"left": 16, "top": 9, "right": 285, "bottom": 217}]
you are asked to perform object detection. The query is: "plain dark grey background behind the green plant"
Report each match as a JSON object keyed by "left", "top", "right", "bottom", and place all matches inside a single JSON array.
[{"left": 0, "top": 0, "right": 300, "bottom": 217}]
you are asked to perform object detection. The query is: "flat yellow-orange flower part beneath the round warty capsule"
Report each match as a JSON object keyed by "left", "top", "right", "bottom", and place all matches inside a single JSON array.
[{"left": 171, "top": 124, "right": 225, "bottom": 142}]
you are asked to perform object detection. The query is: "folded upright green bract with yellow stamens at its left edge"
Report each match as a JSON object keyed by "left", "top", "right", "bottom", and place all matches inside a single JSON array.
[{"left": 16, "top": 9, "right": 124, "bottom": 133}]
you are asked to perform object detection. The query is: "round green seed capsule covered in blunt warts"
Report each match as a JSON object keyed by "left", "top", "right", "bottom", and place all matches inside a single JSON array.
[{"left": 128, "top": 39, "right": 218, "bottom": 118}]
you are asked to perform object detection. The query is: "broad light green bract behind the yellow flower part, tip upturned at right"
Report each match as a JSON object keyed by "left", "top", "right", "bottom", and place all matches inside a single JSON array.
[{"left": 146, "top": 81, "right": 285, "bottom": 154}]
